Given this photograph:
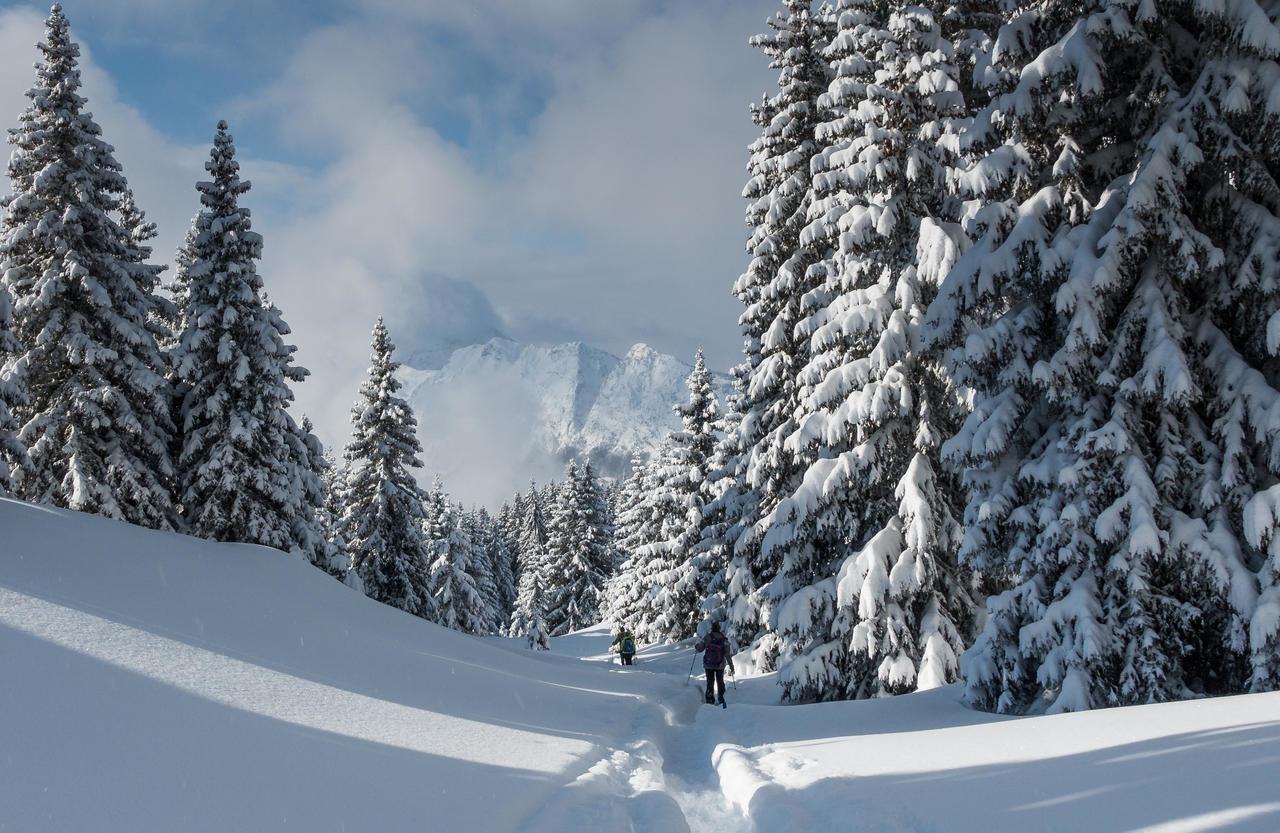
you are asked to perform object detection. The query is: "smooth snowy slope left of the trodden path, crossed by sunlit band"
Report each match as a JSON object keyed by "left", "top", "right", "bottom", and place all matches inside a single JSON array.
[{"left": 0, "top": 500, "right": 675, "bottom": 833}]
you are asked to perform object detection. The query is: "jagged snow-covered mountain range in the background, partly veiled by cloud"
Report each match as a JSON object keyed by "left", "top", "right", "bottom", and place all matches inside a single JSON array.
[{"left": 401, "top": 338, "right": 730, "bottom": 505}]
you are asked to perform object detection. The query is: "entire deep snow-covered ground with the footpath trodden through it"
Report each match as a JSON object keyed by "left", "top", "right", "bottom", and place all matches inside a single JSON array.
[{"left": 0, "top": 499, "right": 1280, "bottom": 833}]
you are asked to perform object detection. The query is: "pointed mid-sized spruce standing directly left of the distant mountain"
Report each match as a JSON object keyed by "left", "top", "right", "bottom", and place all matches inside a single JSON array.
[{"left": 340, "top": 319, "right": 435, "bottom": 618}]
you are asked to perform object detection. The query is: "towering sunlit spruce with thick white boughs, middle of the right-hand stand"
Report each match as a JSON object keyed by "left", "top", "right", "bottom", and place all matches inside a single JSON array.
[{"left": 762, "top": 0, "right": 972, "bottom": 700}]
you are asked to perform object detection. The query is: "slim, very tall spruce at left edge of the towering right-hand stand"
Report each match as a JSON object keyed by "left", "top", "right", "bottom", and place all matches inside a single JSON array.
[{"left": 733, "top": 0, "right": 831, "bottom": 668}]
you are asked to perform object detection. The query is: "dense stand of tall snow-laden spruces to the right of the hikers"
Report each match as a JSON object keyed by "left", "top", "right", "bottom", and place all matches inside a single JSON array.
[{"left": 611, "top": 0, "right": 1280, "bottom": 713}]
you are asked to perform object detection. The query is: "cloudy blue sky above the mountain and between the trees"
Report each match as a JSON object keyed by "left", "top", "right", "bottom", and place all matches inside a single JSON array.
[{"left": 0, "top": 0, "right": 777, "bottom": 496}]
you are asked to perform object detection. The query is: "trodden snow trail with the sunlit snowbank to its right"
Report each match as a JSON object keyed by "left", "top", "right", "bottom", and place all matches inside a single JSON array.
[{"left": 553, "top": 632, "right": 1280, "bottom": 833}]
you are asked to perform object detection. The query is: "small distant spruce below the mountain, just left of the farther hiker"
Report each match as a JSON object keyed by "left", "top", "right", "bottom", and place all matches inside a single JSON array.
[{"left": 547, "top": 462, "right": 612, "bottom": 636}]
